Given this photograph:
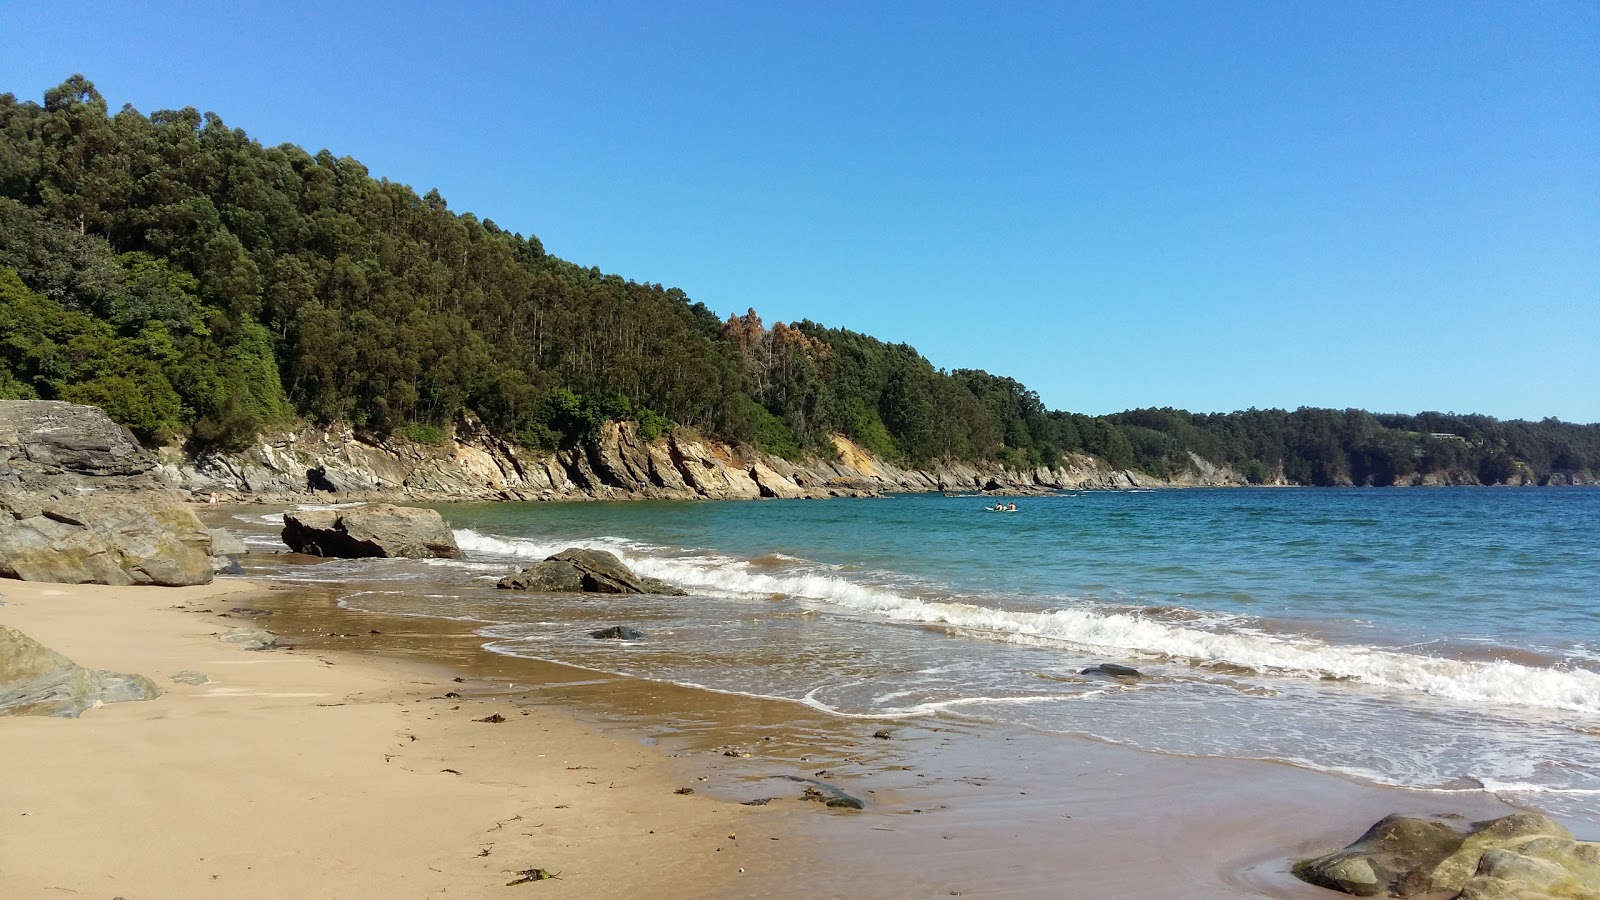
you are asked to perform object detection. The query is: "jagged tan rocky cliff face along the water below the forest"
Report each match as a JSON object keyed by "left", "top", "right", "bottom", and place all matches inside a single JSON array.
[{"left": 157, "top": 421, "right": 1245, "bottom": 501}]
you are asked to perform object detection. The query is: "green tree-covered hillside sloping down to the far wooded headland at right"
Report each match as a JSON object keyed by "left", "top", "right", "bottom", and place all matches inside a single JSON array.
[{"left": 0, "top": 75, "right": 1600, "bottom": 485}]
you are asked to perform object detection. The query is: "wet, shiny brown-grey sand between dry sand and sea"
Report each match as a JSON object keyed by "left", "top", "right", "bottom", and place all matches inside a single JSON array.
[{"left": 232, "top": 585, "right": 1510, "bottom": 898}]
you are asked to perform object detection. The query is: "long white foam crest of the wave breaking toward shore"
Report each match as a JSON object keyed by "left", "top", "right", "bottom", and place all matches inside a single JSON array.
[{"left": 444, "top": 530, "right": 1600, "bottom": 714}]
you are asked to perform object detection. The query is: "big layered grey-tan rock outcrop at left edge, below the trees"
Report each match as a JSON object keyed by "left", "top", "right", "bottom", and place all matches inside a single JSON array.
[{"left": 0, "top": 400, "right": 211, "bottom": 585}]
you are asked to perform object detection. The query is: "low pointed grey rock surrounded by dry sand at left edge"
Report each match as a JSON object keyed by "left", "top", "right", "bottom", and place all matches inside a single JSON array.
[{"left": 0, "top": 625, "right": 162, "bottom": 719}]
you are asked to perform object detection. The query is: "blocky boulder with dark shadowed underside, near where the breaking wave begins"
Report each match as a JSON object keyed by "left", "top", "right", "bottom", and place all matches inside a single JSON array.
[{"left": 283, "top": 503, "right": 462, "bottom": 559}]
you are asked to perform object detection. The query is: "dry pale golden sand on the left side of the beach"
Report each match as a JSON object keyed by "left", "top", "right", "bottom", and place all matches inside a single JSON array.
[{"left": 0, "top": 581, "right": 789, "bottom": 900}]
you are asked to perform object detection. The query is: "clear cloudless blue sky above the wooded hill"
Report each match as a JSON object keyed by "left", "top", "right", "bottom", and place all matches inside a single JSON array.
[{"left": 0, "top": 0, "right": 1600, "bottom": 421}]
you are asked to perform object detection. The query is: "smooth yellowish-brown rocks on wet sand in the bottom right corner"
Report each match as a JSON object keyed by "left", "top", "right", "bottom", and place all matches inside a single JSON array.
[{"left": 1294, "top": 812, "right": 1600, "bottom": 900}]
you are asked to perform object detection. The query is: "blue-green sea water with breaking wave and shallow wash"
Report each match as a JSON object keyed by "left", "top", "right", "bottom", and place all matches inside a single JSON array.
[{"left": 233, "top": 488, "right": 1600, "bottom": 823}]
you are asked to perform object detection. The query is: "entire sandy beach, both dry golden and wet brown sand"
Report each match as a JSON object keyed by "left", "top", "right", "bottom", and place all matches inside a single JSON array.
[{"left": 0, "top": 570, "right": 1529, "bottom": 900}]
